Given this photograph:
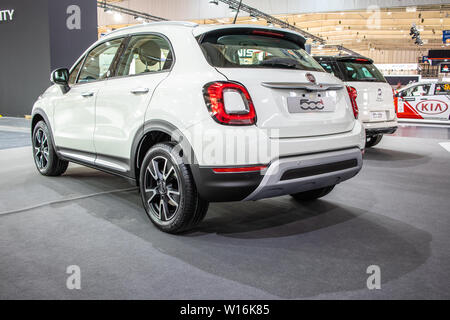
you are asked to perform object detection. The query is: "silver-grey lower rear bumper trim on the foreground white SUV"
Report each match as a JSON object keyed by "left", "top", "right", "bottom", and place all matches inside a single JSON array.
[{"left": 244, "top": 148, "right": 362, "bottom": 201}]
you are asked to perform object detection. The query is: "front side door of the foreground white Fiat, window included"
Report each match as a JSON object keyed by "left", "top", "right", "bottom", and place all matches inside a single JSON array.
[{"left": 54, "top": 39, "right": 122, "bottom": 162}]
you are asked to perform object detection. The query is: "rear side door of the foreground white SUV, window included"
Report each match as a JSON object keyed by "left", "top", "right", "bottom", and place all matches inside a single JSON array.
[{"left": 94, "top": 34, "right": 173, "bottom": 173}]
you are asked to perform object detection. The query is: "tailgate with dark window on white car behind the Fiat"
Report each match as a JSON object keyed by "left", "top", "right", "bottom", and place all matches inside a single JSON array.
[{"left": 337, "top": 58, "right": 395, "bottom": 122}]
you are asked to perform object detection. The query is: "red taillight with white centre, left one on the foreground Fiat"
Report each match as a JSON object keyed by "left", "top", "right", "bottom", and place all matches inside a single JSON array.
[{"left": 203, "top": 81, "right": 256, "bottom": 126}]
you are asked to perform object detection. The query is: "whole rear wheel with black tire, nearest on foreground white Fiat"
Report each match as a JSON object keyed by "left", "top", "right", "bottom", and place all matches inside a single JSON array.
[{"left": 139, "top": 143, "right": 209, "bottom": 234}]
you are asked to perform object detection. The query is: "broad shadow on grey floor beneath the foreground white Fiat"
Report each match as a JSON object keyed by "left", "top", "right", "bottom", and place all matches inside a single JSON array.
[{"left": 78, "top": 186, "right": 431, "bottom": 299}]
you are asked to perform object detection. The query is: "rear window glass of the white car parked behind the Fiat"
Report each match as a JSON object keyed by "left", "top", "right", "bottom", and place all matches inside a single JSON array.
[{"left": 339, "top": 61, "right": 386, "bottom": 82}]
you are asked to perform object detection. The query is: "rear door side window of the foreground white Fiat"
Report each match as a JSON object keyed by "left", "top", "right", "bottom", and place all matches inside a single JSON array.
[{"left": 116, "top": 35, "right": 173, "bottom": 76}]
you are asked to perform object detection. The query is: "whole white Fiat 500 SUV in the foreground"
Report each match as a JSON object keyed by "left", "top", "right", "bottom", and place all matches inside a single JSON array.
[{"left": 32, "top": 22, "right": 365, "bottom": 233}]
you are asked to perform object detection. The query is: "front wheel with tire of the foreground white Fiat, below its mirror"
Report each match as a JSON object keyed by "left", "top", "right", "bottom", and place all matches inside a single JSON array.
[{"left": 31, "top": 121, "right": 69, "bottom": 177}]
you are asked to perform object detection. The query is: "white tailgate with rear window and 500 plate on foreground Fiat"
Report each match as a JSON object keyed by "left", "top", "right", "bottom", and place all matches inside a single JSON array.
[{"left": 198, "top": 28, "right": 355, "bottom": 138}]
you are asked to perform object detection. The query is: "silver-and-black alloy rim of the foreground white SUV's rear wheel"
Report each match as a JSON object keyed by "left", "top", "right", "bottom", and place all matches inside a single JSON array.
[{"left": 144, "top": 156, "right": 181, "bottom": 222}]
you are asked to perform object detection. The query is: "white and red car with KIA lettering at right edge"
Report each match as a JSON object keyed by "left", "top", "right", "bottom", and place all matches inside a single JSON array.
[{"left": 396, "top": 82, "right": 450, "bottom": 121}]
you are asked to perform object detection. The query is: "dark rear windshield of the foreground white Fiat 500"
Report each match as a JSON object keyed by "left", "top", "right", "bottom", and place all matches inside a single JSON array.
[{"left": 199, "top": 29, "right": 324, "bottom": 72}]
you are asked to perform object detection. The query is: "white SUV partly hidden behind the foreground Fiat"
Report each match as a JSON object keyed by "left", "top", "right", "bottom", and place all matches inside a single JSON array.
[{"left": 314, "top": 56, "right": 397, "bottom": 148}]
